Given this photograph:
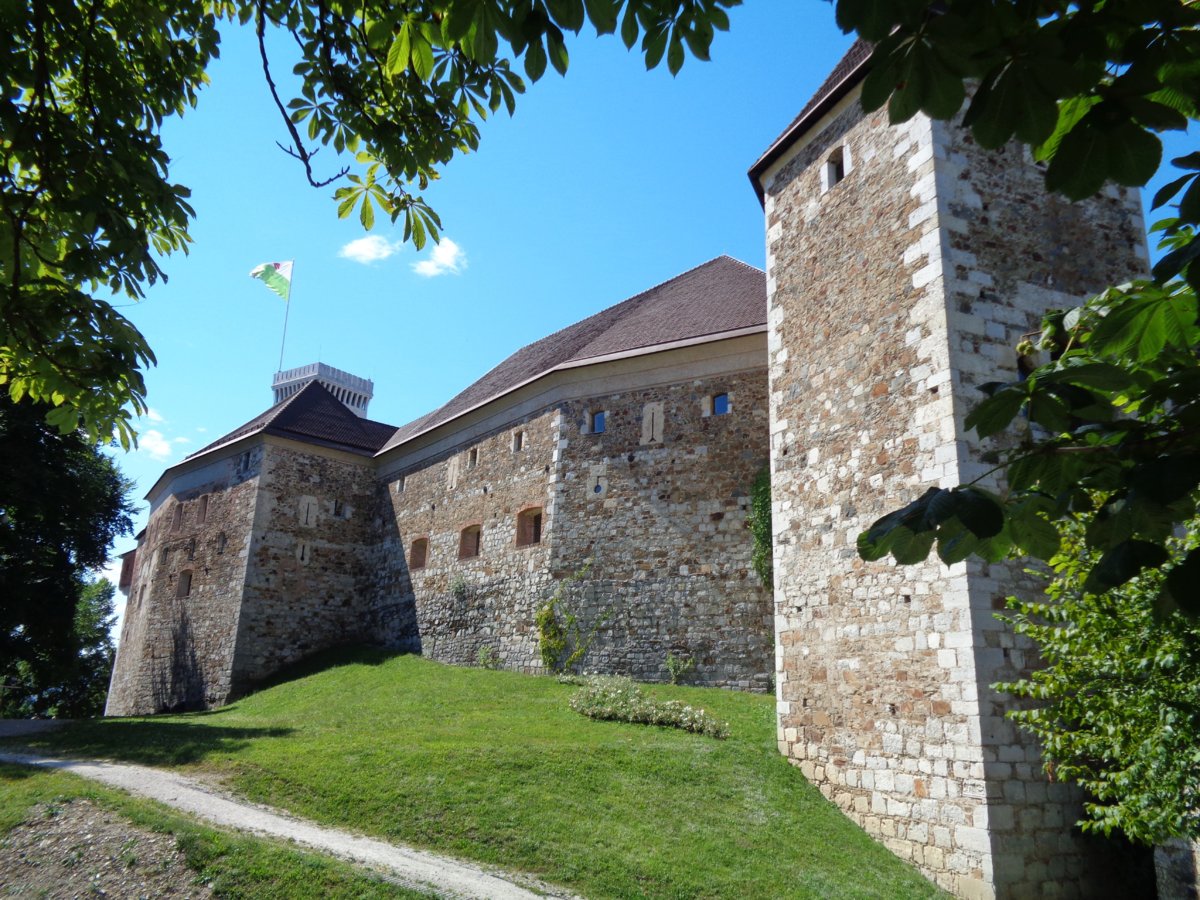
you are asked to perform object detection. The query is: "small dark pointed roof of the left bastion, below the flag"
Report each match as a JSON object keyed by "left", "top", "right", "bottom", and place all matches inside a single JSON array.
[{"left": 187, "top": 382, "right": 396, "bottom": 460}]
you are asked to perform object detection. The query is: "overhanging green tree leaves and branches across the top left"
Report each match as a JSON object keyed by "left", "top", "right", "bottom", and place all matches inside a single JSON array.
[{"left": 0, "top": 0, "right": 740, "bottom": 446}]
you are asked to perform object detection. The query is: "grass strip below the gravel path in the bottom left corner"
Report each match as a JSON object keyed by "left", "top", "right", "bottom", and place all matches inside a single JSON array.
[{"left": 0, "top": 763, "right": 430, "bottom": 900}]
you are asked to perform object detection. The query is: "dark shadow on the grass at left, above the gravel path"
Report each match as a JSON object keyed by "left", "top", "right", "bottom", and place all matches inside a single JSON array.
[{"left": 6, "top": 710, "right": 295, "bottom": 766}]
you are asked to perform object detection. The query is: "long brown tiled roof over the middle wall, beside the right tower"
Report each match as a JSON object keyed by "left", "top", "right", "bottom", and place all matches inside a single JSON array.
[{"left": 380, "top": 256, "right": 767, "bottom": 452}]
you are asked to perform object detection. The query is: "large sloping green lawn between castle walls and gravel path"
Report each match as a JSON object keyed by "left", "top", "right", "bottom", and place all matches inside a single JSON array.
[{"left": 9, "top": 652, "right": 942, "bottom": 898}]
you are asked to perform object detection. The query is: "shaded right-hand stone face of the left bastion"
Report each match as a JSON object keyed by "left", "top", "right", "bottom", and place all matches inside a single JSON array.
[{"left": 225, "top": 442, "right": 409, "bottom": 692}]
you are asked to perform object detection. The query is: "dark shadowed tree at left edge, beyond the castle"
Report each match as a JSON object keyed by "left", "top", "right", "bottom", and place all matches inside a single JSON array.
[{"left": 0, "top": 394, "right": 132, "bottom": 691}]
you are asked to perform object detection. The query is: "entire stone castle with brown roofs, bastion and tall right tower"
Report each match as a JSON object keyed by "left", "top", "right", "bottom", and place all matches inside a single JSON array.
[{"left": 108, "top": 44, "right": 1147, "bottom": 898}]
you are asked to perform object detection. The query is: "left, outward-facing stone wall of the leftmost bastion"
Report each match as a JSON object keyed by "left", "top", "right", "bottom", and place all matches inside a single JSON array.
[{"left": 104, "top": 454, "right": 260, "bottom": 715}]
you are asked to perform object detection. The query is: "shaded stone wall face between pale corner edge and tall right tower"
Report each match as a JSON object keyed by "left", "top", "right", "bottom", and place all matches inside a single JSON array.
[{"left": 551, "top": 371, "right": 773, "bottom": 690}]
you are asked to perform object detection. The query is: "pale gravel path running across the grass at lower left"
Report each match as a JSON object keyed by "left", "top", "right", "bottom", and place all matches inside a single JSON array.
[{"left": 0, "top": 727, "right": 569, "bottom": 900}]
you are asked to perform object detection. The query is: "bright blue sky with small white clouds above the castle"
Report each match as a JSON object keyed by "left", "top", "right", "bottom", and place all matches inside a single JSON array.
[{"left": 98, "top": 0, "right": 1184, "bottom": 619}]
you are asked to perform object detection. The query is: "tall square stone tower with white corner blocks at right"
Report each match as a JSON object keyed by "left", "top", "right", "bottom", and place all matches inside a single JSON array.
[{"left": 750, "top": 44, "right": 1147, "bottom": 898}]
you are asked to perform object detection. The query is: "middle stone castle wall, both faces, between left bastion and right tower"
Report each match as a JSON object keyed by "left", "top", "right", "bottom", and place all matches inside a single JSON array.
[{"left": 379, "top": 372, "right": 772, "bottom": 690}]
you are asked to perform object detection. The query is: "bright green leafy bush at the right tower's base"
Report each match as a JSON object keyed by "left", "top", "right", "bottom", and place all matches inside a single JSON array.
[{"left": 998, "top": 520, "right": 1200, "bottom": 844}]
